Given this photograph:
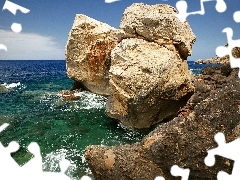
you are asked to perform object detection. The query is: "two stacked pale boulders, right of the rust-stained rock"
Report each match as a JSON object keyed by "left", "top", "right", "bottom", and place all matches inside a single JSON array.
[{"left": 106, "top": 3, "right": 195, "bottom": 129}]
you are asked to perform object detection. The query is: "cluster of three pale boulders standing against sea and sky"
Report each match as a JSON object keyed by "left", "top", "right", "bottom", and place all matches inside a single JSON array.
[{"left": 66, "top": 3, "right": 196, "bottom": 129}]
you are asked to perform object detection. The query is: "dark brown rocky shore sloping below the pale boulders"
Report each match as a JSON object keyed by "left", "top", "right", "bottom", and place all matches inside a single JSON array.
[{"left": 85, "top": 65, "right": 240, "bottom": 180}]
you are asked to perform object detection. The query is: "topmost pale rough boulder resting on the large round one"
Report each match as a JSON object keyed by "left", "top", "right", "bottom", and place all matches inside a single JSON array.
[{"left": 120, "top": 3, "right": 196, "bottom": 59}]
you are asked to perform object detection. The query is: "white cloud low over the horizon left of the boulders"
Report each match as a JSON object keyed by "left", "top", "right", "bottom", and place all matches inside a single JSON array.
[{"left": 0, "top": 30, "right": 64, "bottom": 60}]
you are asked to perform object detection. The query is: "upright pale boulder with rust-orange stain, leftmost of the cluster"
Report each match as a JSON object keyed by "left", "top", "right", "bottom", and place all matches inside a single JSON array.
[{"left": 65, "top": 14, "right": 119, "bottom": 95}]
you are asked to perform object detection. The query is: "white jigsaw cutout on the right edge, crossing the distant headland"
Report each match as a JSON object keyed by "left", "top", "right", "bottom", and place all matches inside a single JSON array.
[{"left": 216, "top": 27, "right": 240, "bottom": 78}]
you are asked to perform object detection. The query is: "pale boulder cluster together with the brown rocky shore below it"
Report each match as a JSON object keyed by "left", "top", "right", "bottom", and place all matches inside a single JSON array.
[{"left": 66, "top": 3, "right": 240, "bottom": 180}]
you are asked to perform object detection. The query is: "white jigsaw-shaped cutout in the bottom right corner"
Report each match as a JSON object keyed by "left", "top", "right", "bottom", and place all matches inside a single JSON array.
[{"left": 204, "top": 133, "right": 240, "bottom": 180}]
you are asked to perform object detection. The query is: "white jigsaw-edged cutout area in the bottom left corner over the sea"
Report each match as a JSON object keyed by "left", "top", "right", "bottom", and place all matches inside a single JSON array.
[{"left": 0, "top": 123, "right": 73, "bottom": 180}]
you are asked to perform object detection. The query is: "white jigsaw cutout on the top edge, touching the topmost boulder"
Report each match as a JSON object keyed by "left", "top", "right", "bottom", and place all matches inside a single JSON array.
[{"left": 176, "top": 0, "right": 227, "bottom": 22}]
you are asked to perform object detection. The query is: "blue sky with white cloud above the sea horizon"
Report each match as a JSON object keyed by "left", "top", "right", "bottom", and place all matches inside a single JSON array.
[{"left": 0, "top": 0, "right": 240, "bottom": 61}]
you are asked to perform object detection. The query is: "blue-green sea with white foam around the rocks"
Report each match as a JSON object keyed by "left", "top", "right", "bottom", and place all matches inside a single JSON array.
[{"left": 0, "top": 60, "right": 214, "bottom": 180}]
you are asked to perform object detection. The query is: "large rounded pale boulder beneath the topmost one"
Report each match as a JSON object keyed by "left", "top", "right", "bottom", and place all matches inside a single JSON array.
[{"left": 106, "top": 38, "right": 194, "bottom": 128}]
